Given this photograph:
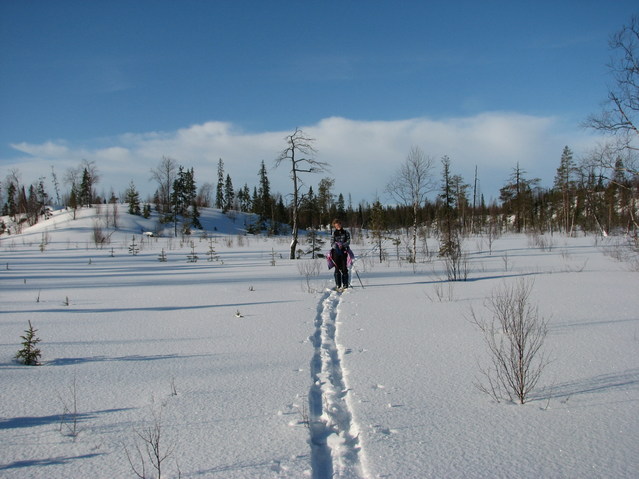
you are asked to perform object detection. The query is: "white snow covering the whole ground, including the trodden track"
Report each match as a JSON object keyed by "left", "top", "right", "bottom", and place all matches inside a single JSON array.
[{"left": 0, "top": 208, "right": 639, "bottom": 479}]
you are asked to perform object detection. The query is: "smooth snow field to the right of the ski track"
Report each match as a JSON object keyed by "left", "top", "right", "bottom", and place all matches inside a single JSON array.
[{"left": 339, "top": 237, "right": 639, "bottom": 478}]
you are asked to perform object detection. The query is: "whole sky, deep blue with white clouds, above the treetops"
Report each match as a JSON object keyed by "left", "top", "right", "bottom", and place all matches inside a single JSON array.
[{"left": 0, "top": 0, "right": 639, "bottom": 201}]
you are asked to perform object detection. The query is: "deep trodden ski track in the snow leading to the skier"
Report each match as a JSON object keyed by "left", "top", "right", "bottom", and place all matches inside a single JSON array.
[{"left": 308, "top": 291, "right": 366, "bottom": 479}]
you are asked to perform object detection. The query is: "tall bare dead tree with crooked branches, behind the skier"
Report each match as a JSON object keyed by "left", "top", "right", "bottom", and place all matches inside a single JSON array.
[{"left": 275, "top": 128, "right": 328, "bottom": 259}]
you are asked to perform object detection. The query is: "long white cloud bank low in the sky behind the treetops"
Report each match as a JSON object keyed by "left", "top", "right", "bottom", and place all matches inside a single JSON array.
[{"left": 1, "top": 112, "right": 595, "bottom": 203}]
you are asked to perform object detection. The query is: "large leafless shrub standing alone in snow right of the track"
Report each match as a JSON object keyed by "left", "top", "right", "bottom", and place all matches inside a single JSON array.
[{"left": 471, "top": 279, "right": 548, "bottom": 404}]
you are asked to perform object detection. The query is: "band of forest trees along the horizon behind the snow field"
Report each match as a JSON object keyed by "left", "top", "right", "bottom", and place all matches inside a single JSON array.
[{"left": 2, "top": 141, "right": 639, "bottom": 240}]
